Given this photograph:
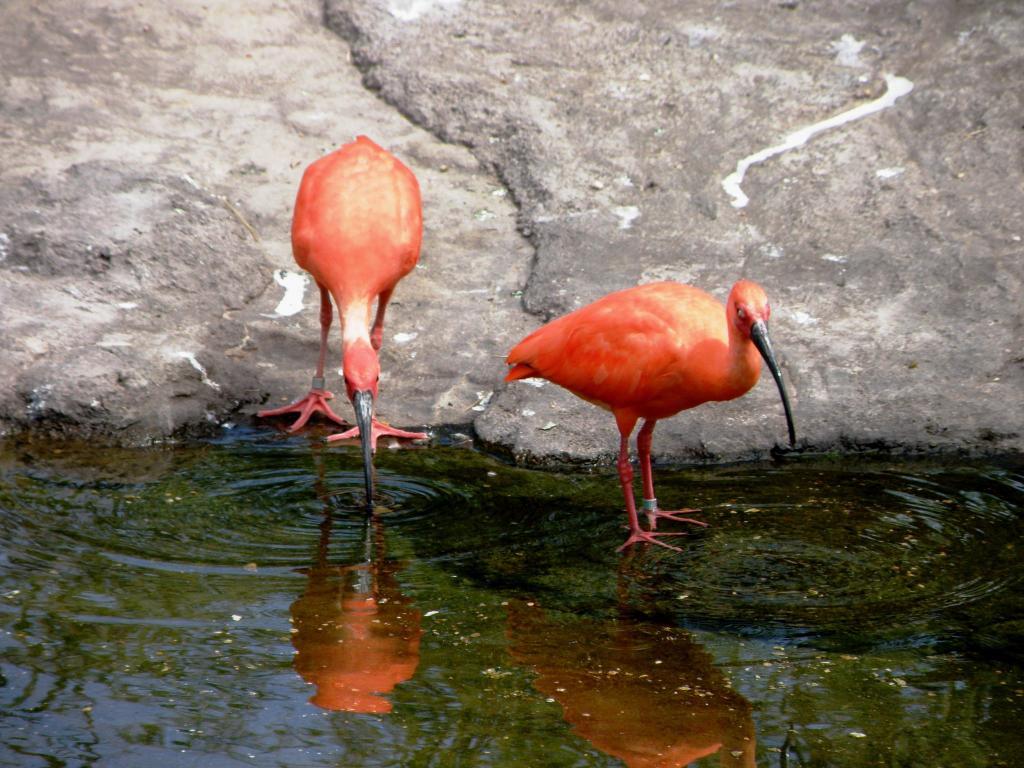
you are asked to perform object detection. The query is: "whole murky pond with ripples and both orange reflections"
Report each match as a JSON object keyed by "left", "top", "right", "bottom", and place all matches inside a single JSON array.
[{"left": 0, "top": 434, "right": 1024, "bottom": 768}]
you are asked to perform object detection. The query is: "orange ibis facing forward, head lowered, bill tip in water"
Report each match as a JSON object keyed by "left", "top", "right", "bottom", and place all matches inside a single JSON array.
[{"left": 258, "top": 136, "right": 427, "bottom": 505}]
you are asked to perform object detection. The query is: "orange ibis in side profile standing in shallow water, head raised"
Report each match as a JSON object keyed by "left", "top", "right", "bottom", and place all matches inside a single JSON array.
[{"left": 505, "top": 280, "right": 797, "bottom": 550}]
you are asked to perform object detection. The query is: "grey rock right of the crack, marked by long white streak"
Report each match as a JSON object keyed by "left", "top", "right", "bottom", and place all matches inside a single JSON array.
[{"left": 328, "top": 0, "right": 1024, "bottom": 459}]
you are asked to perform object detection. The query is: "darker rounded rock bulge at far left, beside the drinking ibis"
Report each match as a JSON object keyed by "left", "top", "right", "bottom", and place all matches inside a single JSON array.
[{"left": 0, "top": 156, "right": 265, "bottom": 441}]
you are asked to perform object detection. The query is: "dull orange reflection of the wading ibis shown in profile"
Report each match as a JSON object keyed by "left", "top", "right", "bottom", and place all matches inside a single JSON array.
[{"left": 508, "top": 601, "right": 756, "bottom": 768}]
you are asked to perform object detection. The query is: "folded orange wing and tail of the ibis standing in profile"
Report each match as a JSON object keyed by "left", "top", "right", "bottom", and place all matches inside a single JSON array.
[{"left": 506, "top": 283, "right": 728, "bottom": 418}]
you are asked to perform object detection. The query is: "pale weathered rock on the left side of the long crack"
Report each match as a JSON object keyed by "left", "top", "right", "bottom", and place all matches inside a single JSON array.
[{"left": 0, "top": 0, "right": 531, "bottom": 443}]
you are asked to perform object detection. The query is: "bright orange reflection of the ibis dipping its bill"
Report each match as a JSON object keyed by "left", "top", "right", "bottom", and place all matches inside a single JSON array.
[{"left": 291, "top": 456, "right": 423, "bottom": 714}]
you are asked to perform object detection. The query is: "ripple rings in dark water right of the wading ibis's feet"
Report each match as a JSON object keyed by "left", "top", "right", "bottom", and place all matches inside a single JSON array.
[{"left": 614, "top": 462, "right": 1022, "bottom": 644}]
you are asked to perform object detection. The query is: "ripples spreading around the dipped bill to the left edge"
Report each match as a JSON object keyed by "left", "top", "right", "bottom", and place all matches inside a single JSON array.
[{"left": 4, "top": 450, "right": 462, "bottom": 574}]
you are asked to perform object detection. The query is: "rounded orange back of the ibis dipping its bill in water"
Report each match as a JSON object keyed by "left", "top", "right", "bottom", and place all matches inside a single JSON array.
[{"left": 292, "top": 136, "right": 423, "bottom": 305}]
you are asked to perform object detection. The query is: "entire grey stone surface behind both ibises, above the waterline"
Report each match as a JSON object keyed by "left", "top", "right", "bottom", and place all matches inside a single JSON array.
[{"left": 0, "top": 0, "right": 1024, "bottom": 461}]
